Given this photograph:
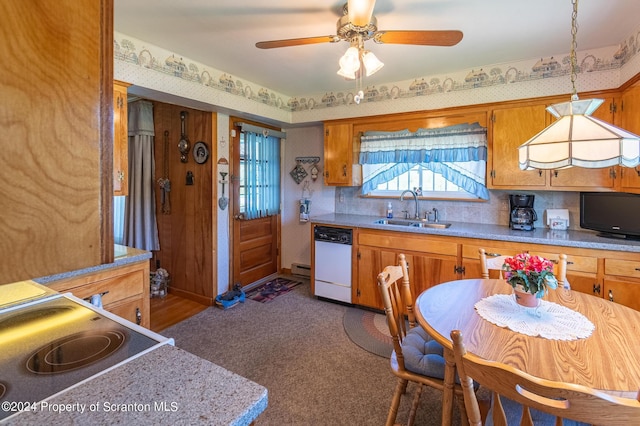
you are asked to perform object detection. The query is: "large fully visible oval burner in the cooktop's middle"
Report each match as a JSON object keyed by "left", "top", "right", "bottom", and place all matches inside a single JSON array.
[{"left": 27, "top": 330, "right": 126, "bottom": 374}]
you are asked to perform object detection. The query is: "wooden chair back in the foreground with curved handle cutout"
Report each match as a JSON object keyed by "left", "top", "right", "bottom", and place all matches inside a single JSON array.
[{"left": 451, "top": 330, "right": 640, "bottom": 426}]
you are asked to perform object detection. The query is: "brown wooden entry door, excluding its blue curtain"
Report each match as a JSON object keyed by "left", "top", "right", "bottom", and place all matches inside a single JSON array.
[{"left": 229, "top": 118, "right": 280, "bottom": 287}]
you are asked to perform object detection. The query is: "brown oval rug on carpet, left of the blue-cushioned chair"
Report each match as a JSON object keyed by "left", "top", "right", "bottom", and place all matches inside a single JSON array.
[{"left": 342, "top": 307, "right": 393, "bottom": 358}]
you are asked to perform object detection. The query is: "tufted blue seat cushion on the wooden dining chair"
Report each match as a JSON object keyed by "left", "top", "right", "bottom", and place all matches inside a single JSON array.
[{"left": 402, "top": 327, "right": 445, "bottom": 379}]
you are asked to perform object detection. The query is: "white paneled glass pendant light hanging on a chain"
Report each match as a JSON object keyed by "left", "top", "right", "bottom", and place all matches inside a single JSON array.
[{"left": 518, "top": 0, "right": 640, "bottom": 170}]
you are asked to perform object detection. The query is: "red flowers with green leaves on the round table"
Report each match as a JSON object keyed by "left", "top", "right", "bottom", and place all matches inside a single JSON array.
[{"left": 502, "top": 253, "right": 558, "bottom": 298}]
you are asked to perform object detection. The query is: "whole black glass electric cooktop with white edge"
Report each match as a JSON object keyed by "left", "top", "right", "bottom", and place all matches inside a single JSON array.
[{"left": 0, "top": 294, "right": 173, "bottom": 423}]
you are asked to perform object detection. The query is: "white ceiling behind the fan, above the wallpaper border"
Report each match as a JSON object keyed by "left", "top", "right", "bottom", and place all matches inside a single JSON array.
[{"left": 115, "top": 0, "right": 640, "bottom": 96}]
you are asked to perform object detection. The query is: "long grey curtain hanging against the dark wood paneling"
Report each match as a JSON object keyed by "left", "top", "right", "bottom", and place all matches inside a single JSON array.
[{"left": 124, "top": 100, "right": 160, "bottom": 250}]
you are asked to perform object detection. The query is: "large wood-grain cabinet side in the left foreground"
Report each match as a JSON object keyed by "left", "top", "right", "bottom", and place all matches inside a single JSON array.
[{"left": 0, "top": 0, "right": 113, "bottom": 284}]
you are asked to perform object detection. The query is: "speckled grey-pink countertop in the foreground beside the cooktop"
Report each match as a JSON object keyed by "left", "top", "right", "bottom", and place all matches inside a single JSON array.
[{"left": 5, "top": 345, "right": 268, "bottom": 426}]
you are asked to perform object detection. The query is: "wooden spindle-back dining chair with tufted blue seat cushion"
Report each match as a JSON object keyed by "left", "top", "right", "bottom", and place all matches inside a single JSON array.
[{"left": 378, "top": 254, "right": 466, "bottom": 426}]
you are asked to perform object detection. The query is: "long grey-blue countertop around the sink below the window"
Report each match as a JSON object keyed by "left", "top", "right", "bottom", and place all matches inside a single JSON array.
[{"left": 310, "top": 214, "right": 640, "bottom": 253}]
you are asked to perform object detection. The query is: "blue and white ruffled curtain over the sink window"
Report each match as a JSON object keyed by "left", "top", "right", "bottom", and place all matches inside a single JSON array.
[{"left": 359, "top": 123, "right": 489, "bottom": 200}]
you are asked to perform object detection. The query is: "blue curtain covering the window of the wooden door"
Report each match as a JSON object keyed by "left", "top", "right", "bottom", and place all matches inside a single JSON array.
[{"left": 240, "top": 123, "right": 284, "bottom": 219}]
